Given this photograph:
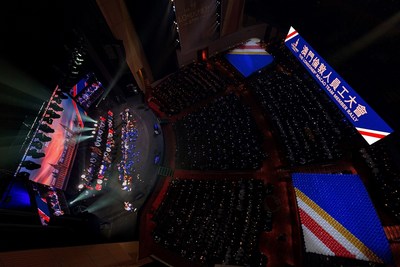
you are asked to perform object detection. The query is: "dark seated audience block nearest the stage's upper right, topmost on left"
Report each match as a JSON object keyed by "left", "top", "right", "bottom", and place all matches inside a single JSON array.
[{"left": 152, "top": 63, "right": 231, "bottom": 115}]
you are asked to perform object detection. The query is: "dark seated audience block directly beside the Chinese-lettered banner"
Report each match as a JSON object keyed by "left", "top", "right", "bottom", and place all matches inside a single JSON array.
[{"left": 247, "top": 70, "right": 344, "bottom": 166}]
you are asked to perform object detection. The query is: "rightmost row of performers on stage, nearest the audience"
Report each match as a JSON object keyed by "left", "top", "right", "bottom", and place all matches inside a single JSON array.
[{"left": 117, "top": 108, "right": 140, "bottom": 191}]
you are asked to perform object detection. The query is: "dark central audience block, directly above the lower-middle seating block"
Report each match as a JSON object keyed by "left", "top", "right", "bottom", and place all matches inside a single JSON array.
[{"left": 174, "top": 94, "right": 265, "bottom": 170}]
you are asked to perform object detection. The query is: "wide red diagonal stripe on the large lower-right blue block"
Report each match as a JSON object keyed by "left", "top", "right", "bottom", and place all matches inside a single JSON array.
[{"left": 299, "top": 208, "right": 355, "bottom": 258}]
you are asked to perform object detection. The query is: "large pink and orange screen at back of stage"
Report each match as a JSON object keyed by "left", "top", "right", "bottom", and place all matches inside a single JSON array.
[{"left": 17, "top": 89, "right": 84, "bottom": 189}]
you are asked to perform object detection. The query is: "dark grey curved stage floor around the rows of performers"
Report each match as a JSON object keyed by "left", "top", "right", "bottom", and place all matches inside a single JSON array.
[{"left": 67, "top": 95, "right": 164, "bottom": 242}]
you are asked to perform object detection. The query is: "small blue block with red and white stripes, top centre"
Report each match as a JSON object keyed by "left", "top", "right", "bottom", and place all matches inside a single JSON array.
[{"left": 225, "top": 38, "right": 274, "bottom": 77}]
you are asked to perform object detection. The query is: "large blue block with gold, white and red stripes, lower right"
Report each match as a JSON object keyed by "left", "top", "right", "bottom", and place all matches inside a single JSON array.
[{"left": 292, "top": 173, "right": 392, "bottom": 263}]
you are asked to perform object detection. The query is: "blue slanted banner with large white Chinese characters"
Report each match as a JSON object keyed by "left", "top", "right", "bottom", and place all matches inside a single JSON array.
[{"left": 285, "top": 27, "right": 393, "bottom": 145}]
